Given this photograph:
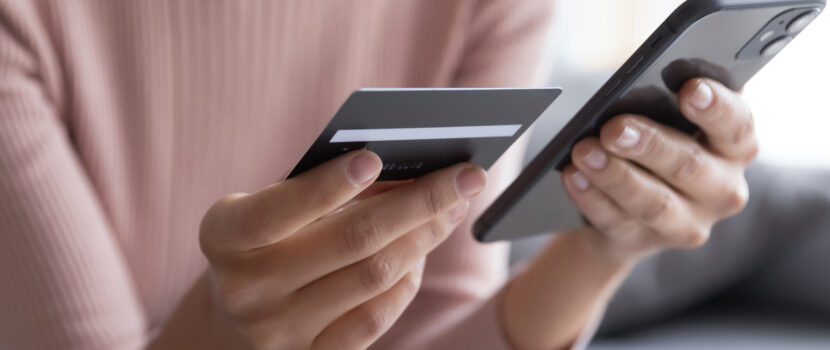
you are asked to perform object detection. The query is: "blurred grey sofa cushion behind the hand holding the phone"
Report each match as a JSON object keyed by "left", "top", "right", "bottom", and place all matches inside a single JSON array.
[{"left": 600, "top": 164, "right": 830, "bottom": 334}]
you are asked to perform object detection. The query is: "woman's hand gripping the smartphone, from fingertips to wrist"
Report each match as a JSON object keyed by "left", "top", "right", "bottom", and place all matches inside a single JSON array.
[{"left": 562, "top": 79, "right": 758, "bottom": 260}]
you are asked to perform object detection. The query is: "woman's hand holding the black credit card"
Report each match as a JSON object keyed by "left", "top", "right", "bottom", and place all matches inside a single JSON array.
[{"left": 154, "top": 151, "right": 486, "bottom": 349}]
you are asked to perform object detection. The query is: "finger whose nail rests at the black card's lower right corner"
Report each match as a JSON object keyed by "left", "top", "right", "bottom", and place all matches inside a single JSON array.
[{"left": 278, "top": 164, "right": 486, "bottom": 279}]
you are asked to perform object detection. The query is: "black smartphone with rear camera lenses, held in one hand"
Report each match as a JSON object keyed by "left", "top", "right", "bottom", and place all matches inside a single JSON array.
[{"left": 473, "top": 0, "right": 826, "bottom": 242}]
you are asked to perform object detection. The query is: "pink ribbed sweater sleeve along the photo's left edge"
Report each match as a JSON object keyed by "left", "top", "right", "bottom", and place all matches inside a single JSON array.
[{"left": 0, "top": 1, "right": 144, "bottom": 349}]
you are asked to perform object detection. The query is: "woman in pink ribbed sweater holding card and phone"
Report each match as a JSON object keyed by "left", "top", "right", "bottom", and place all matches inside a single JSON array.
[{"left": 0, "top": 0, "right": 757, "bottom": 349}]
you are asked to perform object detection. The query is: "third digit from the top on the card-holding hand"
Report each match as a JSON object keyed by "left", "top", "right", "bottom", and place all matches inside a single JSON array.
[{"left": 291, "top": 202, "right": 470, "bottom": 329}]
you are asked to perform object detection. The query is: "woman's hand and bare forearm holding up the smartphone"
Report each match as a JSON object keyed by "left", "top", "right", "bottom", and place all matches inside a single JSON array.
[{"left": 502, "top": 79, "right": 758, "bottom": 349}]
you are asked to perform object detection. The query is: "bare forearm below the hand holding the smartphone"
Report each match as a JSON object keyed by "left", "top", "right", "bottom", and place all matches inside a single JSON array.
[{"left": 501, "top": 228, "right": 633, "bottom": 349}]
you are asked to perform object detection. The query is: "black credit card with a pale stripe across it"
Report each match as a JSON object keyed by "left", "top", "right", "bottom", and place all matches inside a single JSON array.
[{"left": 288, "top": 88, "right": 562, "bottom": 181}]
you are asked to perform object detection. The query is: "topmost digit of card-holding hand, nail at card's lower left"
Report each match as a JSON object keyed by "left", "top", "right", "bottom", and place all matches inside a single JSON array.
[{"left": 202, "top": 151, "right": 382, "bottom": 251}]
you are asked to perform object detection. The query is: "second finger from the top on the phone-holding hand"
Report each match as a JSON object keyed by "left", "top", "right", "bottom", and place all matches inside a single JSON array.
[{"left": 600, "top": 115, "right": 743, "bottom": 202}]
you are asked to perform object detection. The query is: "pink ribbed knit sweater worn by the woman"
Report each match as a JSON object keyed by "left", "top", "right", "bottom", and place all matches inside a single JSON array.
[{"left": 0, "top": 0, "right": 564, "bottom": 349}]
